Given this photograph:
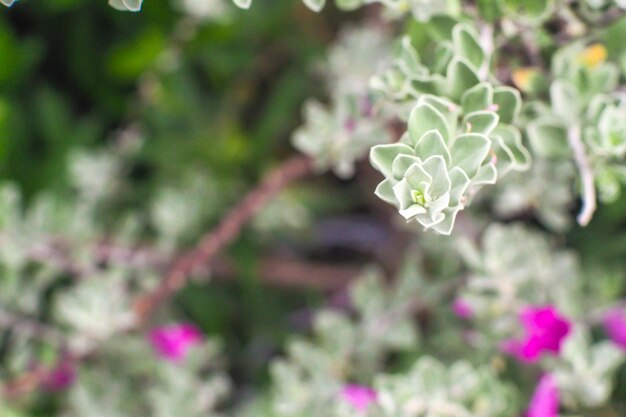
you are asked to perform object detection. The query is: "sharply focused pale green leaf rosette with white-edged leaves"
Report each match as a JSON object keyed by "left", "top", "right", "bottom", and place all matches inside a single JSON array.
[{"left": 370, "top": 84, "right": 530, "bottom": 235}]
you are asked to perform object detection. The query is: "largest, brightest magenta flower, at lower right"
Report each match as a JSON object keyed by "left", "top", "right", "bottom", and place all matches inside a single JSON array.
[{"left": 502, "top": 306, "right": 572, "bottom": 362}]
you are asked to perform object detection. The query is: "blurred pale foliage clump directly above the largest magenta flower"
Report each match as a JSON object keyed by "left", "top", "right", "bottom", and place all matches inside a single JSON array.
[{"left": 459, "top": 224, "right": 582, "bottom": 333}]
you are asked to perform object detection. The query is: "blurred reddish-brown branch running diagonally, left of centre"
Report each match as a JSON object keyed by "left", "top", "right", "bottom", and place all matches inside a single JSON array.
[{"left": 134, "top": 155, "right": 313, "bottom": 323}]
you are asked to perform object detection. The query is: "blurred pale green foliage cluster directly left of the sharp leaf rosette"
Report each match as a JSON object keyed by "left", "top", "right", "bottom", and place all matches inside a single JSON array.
[{"left": 293, "top": 28, "right": 390, "bottom": 178}]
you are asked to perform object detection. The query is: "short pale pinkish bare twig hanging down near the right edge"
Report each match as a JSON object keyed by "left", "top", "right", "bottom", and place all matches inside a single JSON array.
[{"left": 567, "top": 125, "right": 596, "bottom": 226}]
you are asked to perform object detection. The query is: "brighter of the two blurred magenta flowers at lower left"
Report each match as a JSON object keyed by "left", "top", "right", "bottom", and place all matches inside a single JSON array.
[{"left": 149, "top": 323, "right": 202, "bottom": 362}]
